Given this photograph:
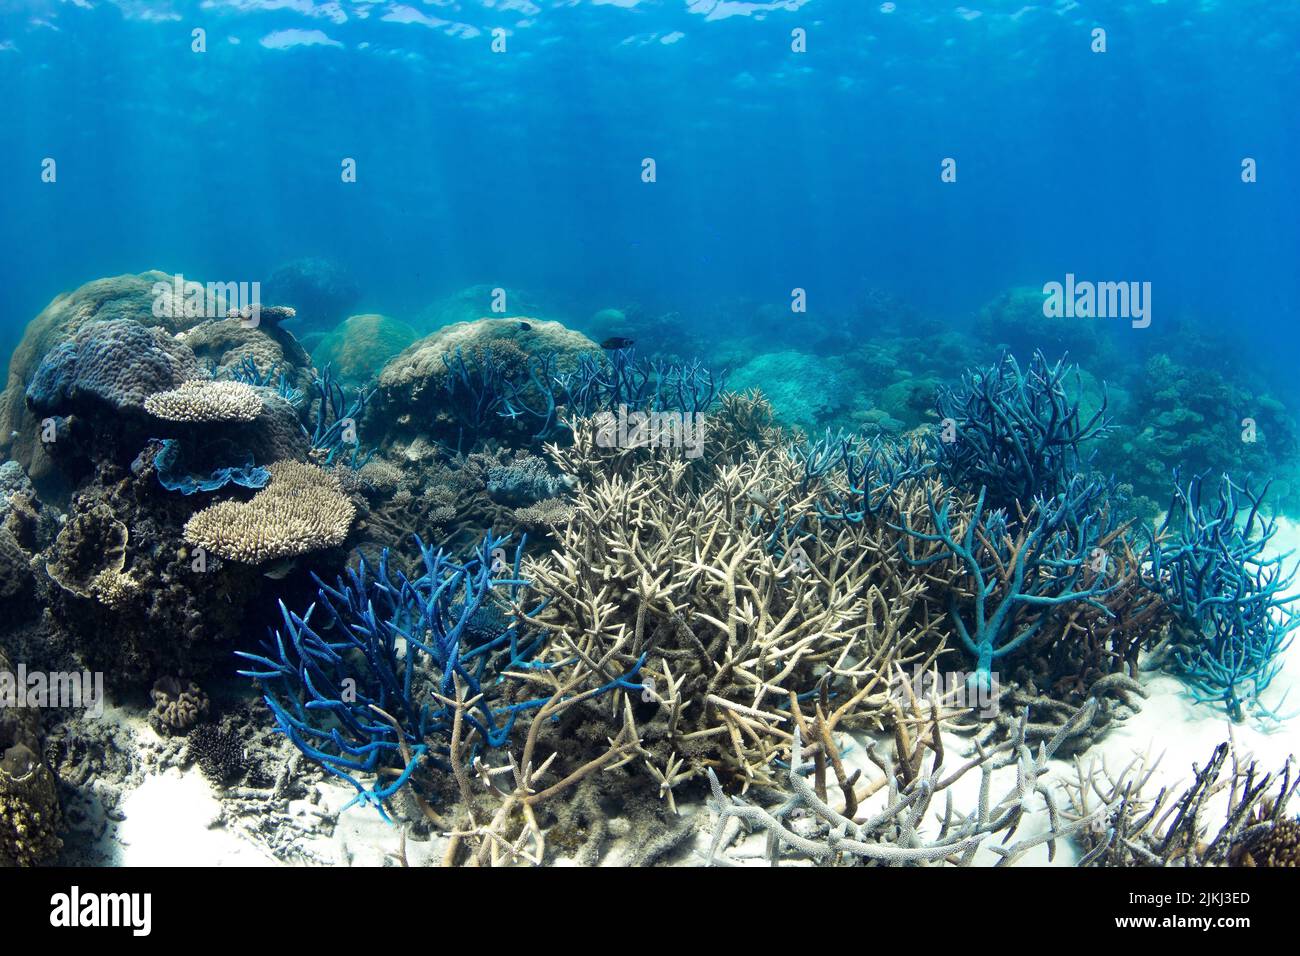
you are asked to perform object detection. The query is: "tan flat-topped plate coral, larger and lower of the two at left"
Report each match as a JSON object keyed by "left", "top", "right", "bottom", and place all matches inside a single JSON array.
[{"left": 185, "top": 460, "right": 356, "bottom": 564}]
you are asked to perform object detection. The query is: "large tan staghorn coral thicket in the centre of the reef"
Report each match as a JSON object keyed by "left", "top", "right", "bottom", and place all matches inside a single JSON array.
[{"left": 527, "top": 420, "right": 941, "bottom": 797}]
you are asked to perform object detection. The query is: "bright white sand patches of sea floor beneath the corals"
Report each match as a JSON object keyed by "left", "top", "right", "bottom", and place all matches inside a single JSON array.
[{"left": 77, "top": 519, "right": 1300, "bottom": 866}]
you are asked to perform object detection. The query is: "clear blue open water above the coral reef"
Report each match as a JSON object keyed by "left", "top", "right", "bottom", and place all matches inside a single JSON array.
[{"left": 0, "top": 0, "right": 1300, "bottom": 390}]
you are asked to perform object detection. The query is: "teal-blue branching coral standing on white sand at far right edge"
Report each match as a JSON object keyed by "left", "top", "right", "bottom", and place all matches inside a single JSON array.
[{"left": 1145, "top": 472, "right": 1300, "bottom": 721}]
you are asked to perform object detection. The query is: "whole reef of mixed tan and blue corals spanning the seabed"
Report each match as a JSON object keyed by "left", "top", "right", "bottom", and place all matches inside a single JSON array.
[{"left": 0, "top": 270, "right": 1300, "bottom": 866}]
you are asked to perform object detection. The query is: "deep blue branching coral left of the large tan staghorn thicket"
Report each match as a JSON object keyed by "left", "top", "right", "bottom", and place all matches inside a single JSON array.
[{"left": 237, "top": 535, "right": 641, "bottom": 818}]
